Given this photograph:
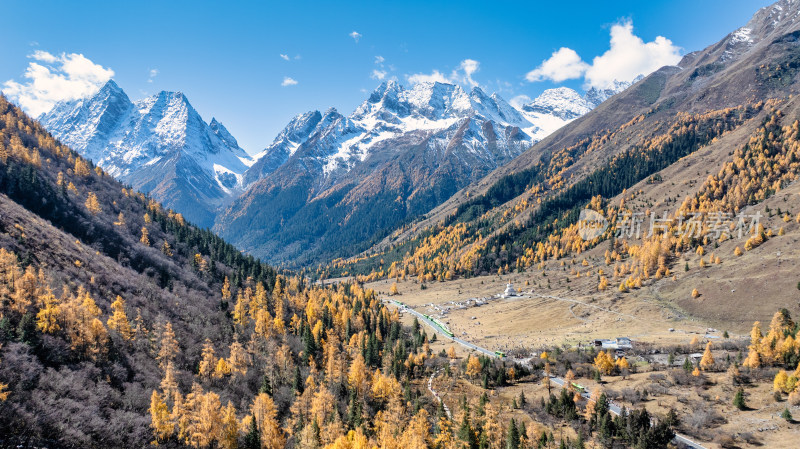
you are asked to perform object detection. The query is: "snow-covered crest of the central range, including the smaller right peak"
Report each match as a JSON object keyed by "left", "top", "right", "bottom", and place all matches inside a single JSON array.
[{"left": 244, "top": 79, "right": 638, "bottom": 186}]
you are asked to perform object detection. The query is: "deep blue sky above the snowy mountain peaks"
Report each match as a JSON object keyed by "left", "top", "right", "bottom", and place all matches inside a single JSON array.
[{"left": 0, "top": 0, "right": 772, "bottom": 153}]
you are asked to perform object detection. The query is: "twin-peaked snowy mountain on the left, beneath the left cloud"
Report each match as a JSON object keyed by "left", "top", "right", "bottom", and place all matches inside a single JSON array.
[{"left": 39, "top": 81, "right": 253, "bottom": 226}]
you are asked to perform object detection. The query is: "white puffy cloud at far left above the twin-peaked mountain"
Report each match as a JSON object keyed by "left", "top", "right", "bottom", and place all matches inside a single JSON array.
[{"left": 3, "top": 50, "right": 114, "bottom": 117}]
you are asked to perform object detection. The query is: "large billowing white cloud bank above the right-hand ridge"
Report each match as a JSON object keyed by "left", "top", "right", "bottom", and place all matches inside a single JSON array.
[{"left": 525, "top": 21, "right": 681, "bottom": 88}]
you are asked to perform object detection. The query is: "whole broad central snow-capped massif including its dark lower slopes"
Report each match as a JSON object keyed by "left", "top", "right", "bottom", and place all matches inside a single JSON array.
[{"left": 215, "top": 81, "right": 636, "bottom": 264}]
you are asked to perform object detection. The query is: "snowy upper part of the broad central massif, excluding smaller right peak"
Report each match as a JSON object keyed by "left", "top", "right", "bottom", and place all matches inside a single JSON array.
[{"left": 245, "top": 81, "right": 532, "bottom": 184}]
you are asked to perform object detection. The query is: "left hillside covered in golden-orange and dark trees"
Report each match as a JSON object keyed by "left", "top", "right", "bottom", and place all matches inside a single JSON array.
[{"left": 0, "top": 97, "right": 450, "bottom": 447}]
